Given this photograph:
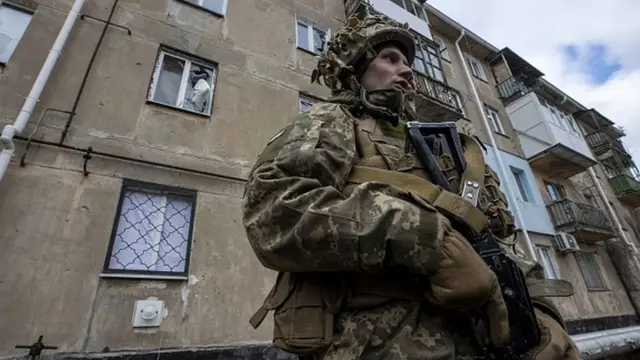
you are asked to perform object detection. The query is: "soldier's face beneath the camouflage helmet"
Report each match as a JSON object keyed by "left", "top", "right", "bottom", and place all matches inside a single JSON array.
[{"left": 361, "top": 45, "right": 413, "bottom": 90}]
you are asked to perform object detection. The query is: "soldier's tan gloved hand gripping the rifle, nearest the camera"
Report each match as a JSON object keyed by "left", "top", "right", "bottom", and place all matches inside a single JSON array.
[{"left": 425, "top": 214, "right": 509, "bottom": 347}]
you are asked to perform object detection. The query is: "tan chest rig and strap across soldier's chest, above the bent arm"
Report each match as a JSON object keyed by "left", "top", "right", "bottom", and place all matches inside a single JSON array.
[{"left": 343, "top": 118, "right": 513, "bottom": 237}]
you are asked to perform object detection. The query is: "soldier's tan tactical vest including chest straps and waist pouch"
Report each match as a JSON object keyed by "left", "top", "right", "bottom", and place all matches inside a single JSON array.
[{"left": 250, "top": 114, "right": 513, "bottom": 355}]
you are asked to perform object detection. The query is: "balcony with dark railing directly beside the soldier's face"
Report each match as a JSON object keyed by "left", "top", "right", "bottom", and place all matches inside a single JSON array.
[{"left": 413, "top": 71, "right": 463, "bottom": 122}]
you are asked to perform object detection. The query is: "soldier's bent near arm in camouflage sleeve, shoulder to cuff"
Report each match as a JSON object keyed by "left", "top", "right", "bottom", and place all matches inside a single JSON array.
[{"left": 243, "top": 104, "right": 443, "bottom": 275}]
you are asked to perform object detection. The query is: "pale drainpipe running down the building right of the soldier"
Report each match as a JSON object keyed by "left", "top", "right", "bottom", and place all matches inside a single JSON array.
[{"left": 455, "top": 29, "right": 538, "bottom": 261}]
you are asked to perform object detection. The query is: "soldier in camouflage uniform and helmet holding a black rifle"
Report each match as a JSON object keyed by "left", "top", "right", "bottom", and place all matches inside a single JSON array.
[{"left": 243, "top": 8, "right": 579, "bottom": 360}]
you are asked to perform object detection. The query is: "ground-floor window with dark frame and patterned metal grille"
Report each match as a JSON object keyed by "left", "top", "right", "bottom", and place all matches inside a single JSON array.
[{"left": 101, "top": 179, "right": 197, "bottom": 278}]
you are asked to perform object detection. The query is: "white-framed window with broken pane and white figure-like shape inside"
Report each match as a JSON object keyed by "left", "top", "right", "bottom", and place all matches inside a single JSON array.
[{"left": 149, "top": 51, "right": 216, "bottom": 115}]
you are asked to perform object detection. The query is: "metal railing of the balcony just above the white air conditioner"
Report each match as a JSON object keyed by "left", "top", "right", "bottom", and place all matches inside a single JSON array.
[{"left": 547, "top": 199, "right": 613, "bottom": 233}]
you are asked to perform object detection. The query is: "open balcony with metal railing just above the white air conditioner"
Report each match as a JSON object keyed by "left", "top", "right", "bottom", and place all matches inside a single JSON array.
[{"left": 547, "top": 199, "right": 615, "bottom": 244}]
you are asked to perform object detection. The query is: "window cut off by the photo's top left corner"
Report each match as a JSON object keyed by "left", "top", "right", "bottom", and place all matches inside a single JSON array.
[{"left": 0, "top": 2, "right": 32, "bottom": 64}]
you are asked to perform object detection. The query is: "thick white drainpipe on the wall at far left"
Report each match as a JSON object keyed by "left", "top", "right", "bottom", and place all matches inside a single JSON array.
[{"left": 0, "top": 0, "right": 85, "bottom": 182}]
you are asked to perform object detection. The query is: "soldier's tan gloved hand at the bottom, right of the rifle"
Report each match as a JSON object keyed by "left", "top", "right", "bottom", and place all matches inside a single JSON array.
[{"left": 525, "top": 309, "right": 580, "bottom": 360}]
